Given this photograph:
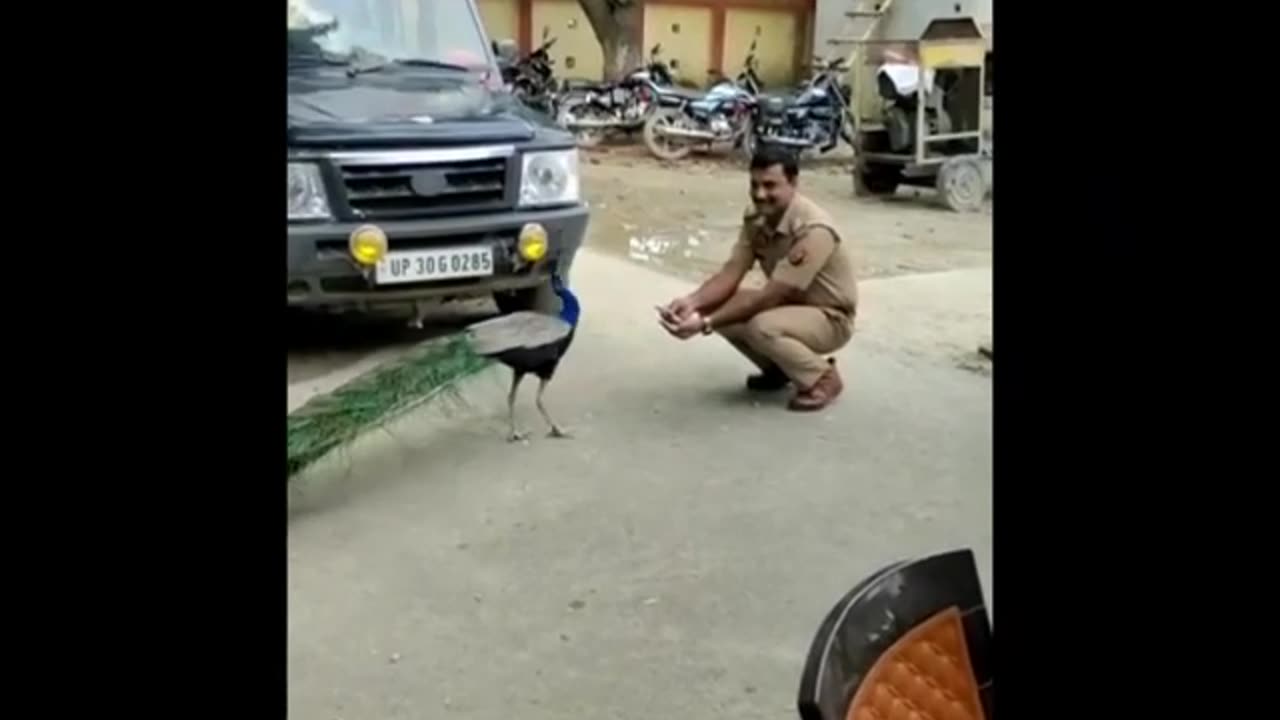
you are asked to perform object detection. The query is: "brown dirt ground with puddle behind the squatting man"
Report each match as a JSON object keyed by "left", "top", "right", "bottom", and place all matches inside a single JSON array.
[{"left": 582, "top": 145, "right": 992, "bottom": 278}]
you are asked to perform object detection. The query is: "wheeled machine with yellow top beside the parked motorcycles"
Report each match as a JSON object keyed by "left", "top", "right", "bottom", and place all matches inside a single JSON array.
[{"left": 854, "top": 18, "right": 988, "bottom": 211}]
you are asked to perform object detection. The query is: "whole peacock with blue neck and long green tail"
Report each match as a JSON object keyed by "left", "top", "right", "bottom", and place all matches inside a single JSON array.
[{"left": 287, "top": 273, "right": 581, "bottom": 478}]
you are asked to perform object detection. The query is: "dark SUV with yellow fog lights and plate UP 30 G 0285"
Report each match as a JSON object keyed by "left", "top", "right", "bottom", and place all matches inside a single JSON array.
[{"left": 288, "top": 0, "right": 588, "bottom": 318}]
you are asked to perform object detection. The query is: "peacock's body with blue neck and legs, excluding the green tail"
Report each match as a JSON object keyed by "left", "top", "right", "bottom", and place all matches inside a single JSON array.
[{"left": 463, "top": 273, "right": 581, "bottom": 442}]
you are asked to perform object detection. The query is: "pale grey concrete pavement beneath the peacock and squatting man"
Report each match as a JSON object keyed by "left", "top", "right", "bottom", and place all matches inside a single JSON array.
[{"left": 288, "top": 252, "right": 992, "bottom": 720}]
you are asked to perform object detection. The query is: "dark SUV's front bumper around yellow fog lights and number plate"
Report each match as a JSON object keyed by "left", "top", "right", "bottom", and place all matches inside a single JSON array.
[{"left": 287, "top": 204, "right": 588, "bottom": 310}]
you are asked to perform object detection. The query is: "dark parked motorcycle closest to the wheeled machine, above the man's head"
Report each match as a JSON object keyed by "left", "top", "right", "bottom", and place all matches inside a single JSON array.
[{"left": 745, "top": 58, "right": 854, "bottom": 154}]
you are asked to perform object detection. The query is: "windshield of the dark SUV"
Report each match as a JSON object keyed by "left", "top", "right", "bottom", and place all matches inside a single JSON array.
[{"left": 288, "top": 0, "right": 489, "bottom": 72}]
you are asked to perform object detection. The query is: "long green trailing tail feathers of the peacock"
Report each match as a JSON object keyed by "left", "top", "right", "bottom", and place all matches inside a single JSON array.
[{"left": 288, "top": 334, "right": 493, "bottom": 478}]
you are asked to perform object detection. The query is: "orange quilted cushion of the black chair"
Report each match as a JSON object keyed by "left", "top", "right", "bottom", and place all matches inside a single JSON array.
[{"left": 845, "top": 607, "right": 983, "bottom": 720}]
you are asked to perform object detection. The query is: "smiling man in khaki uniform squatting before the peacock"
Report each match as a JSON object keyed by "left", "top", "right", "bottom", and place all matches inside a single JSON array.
[{"left": 658, "top": 149, "right": 858, "bottom": 410}]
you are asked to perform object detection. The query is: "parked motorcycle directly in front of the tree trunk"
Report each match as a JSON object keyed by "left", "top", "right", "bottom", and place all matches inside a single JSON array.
[{"left": 557, "top": 42, "right": 675, "bottom": 147}]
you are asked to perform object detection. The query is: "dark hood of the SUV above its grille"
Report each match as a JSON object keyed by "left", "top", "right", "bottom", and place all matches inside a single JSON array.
[{"left": 288, "top": 69, "right": 548, "bottom": 145}]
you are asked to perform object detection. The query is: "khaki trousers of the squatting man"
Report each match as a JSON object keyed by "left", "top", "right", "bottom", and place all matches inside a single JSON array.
[{"left": 717, "top": 305, "right": 854, "bottom": 389}]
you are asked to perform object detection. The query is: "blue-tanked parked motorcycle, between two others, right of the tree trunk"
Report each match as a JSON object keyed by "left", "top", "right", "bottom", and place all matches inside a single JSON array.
[{"left": 644, "top": 40, "right": 760, "bottom": 160}]
